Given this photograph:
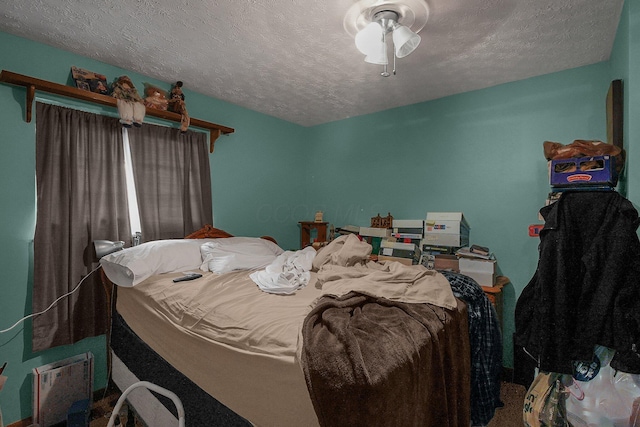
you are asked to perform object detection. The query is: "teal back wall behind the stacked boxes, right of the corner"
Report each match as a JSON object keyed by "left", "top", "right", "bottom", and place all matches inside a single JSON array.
[{"left": 307, "top": 63, "right": 609, "bottom": 372}]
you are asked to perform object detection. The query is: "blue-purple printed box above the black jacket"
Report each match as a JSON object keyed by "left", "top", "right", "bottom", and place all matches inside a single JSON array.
[{"left": 549, "top": 156, "right": 618, "bottom": 187}]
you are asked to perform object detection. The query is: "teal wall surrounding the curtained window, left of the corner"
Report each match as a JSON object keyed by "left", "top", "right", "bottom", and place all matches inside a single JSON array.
[{"left": 0, "top": 33, "right": 309, "bottom": 424}]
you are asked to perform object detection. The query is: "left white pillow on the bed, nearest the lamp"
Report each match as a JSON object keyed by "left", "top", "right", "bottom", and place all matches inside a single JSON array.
[{"left": 100, "top": 239, "right": 211, "bottom": 287}]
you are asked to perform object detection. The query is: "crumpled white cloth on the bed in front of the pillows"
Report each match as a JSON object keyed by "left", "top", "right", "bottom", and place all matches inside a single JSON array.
[{"left": 249, "top": 246, "right": 316, "bottom": 295}]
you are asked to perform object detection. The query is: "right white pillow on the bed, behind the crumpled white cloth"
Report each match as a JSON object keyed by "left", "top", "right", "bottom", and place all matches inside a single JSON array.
[{"left": 200, "top": 237, "right": 284, "bottom": 274}]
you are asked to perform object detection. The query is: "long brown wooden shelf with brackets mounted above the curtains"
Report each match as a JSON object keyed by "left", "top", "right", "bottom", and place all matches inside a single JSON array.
[{"left": 0, "top": 70, "right": 235, "bottom": 153}]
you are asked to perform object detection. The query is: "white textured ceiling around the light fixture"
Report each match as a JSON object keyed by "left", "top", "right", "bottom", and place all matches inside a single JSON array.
[{"left": 0, "top": 0, "right": 623, "bottom": 126}]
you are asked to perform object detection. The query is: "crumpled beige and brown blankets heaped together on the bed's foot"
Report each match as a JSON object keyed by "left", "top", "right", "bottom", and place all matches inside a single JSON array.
[{"left": 300, "top": 235, "right": 471, "bottom": 427}]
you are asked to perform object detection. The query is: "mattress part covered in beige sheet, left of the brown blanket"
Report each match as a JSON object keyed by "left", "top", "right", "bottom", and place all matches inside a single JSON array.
[{"left": 116, "top": 271, "right": 321, "bottom": 426}]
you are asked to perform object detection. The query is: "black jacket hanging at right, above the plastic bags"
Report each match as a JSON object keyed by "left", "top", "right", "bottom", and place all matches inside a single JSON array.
[{"left": 515, "top": 191, "right": 640, "bottom": 374}]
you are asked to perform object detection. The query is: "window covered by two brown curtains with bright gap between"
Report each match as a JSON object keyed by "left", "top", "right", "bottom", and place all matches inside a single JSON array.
[{"left": 32, "top": 102, "right": 213, "bottom": 351}]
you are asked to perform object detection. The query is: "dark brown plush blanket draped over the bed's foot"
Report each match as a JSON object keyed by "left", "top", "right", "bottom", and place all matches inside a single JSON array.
[{"left": 301, "top": 292, "right": 471, "bottom": 427}]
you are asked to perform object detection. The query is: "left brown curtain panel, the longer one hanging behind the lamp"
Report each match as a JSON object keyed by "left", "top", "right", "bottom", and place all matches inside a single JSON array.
[{"left": 32, "top": 103, "right": 131, "bottom": 351}]
